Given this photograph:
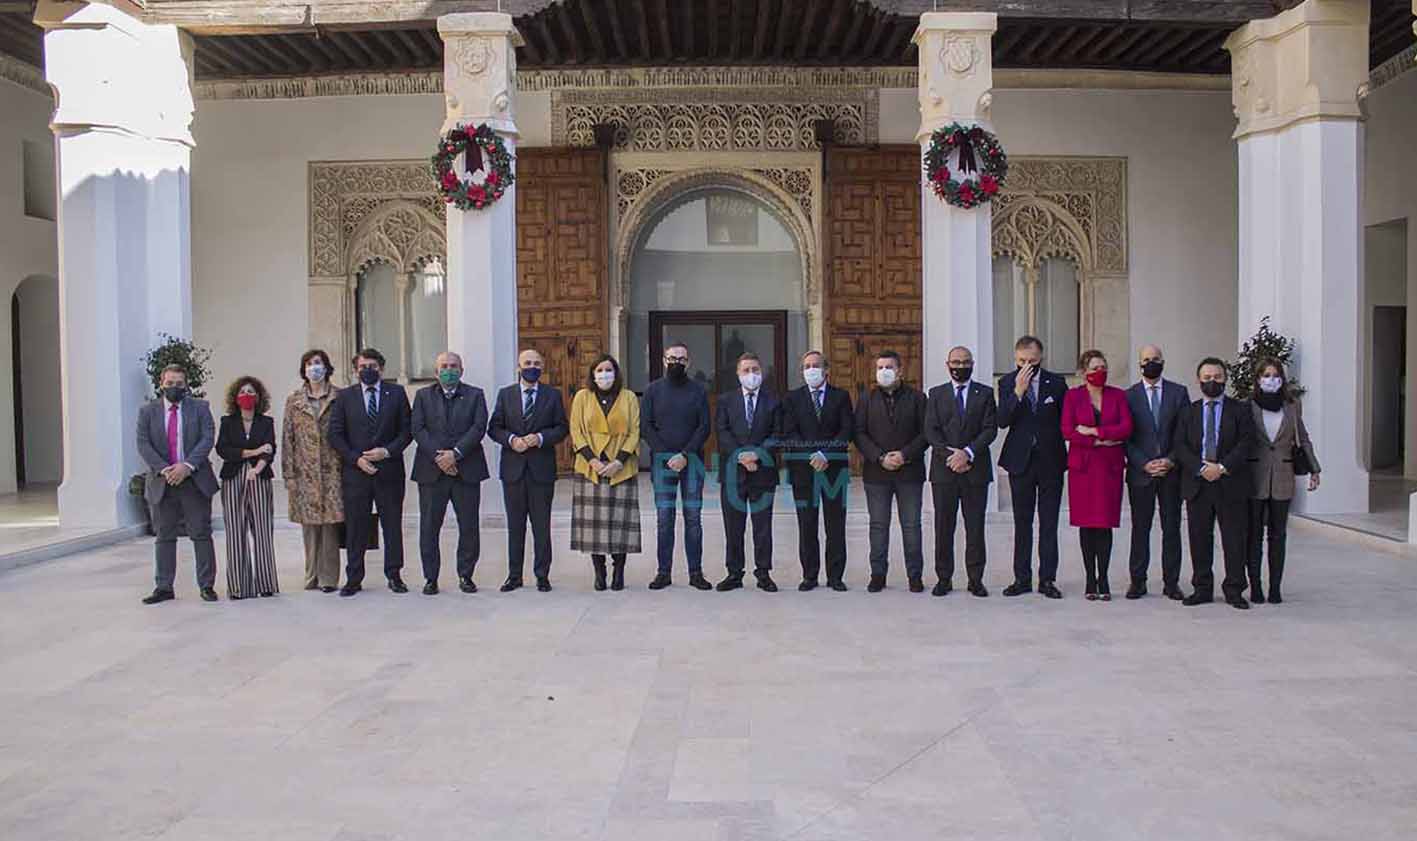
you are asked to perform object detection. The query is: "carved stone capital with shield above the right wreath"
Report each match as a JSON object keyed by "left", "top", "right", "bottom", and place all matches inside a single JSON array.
[{"left": 913, "top": 11, "right": 998, "bottom": 140}]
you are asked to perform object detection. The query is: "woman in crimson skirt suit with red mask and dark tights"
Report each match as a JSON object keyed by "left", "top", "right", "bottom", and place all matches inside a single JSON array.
[{"left": 1061, "top": 350, "right": 1132, "bottom": 602}]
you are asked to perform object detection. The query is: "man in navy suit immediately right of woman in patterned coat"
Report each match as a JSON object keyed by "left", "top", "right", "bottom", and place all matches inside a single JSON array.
[{"left": 330, "top": 347, "right": 414, "bottom": 596}]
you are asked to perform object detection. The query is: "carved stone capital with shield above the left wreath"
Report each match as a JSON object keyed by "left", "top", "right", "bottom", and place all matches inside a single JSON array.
[{"left": 438, "top": 11, "right": 523, "bottom": 137}]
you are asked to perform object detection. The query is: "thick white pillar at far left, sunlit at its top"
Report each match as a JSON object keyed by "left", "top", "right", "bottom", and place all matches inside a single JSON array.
[{"left": 35, "top": 0, "right": 193, "bottom": 528}]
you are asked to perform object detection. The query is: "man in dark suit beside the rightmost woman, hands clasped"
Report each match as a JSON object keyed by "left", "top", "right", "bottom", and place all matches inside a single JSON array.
[{"left": 1175, "top": 357, "right": 1254, "bottom": 610}]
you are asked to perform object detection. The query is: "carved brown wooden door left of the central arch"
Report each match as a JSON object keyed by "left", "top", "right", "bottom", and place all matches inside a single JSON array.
[{"left": 516, "top": 147, "right": 609, "bottom": 473}]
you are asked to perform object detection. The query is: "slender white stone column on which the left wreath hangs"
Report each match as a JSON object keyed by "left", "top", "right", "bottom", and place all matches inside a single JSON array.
[{"left": 438, "top": 11, "right": 521, "bottom": 478}]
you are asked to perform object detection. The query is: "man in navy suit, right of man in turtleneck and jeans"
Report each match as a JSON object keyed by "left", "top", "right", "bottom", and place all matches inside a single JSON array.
[{"left": 716, "top": 353, "right": 782, "bottom": 593}]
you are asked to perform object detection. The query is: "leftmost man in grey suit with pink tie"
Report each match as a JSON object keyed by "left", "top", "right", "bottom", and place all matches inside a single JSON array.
[{"left": 137, "top": 365, "right": 217, "bottom": 605}]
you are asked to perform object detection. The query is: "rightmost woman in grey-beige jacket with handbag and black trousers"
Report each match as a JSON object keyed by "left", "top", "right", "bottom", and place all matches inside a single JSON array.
[{"left": 1247, "top": 360, "right": 1319, "bottom": 605}]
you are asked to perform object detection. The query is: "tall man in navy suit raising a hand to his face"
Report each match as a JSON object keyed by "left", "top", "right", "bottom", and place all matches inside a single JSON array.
[{"left": 999, "top": 336, "right": 1067, "bottom": 599}]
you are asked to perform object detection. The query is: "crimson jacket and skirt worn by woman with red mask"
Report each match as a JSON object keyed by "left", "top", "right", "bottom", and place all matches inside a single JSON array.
[{"left": 1061, "top": 385, "right": 1132, "bottom": 528}]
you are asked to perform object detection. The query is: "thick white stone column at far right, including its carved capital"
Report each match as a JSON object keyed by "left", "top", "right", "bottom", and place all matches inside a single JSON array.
[{"left": 1217, "top": 0, "right": 1369, "bottom": 513}]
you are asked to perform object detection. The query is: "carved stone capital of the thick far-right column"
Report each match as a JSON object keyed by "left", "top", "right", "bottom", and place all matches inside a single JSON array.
[{"left": 1224, "top": 0, "right": 1369, "bottom": 139}]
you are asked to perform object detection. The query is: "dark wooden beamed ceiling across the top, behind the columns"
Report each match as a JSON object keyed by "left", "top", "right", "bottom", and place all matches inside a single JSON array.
[{"left": 0, "top": 0, "right": 1414, "bottom": 79}]
